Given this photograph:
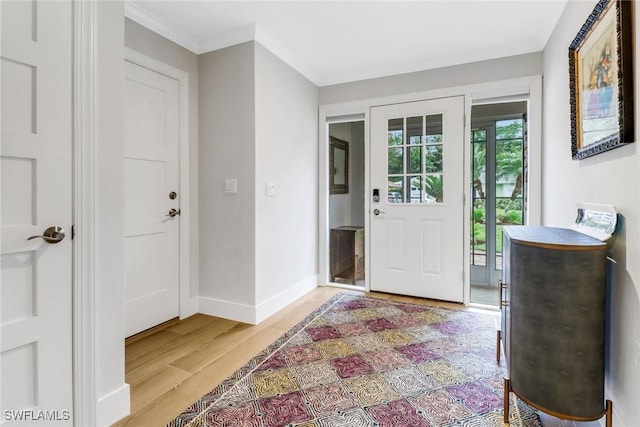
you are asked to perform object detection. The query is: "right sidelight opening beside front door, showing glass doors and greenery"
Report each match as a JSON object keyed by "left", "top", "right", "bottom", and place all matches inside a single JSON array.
[{"left": 470, "top": 100, "right": 528, "bottom": 306}]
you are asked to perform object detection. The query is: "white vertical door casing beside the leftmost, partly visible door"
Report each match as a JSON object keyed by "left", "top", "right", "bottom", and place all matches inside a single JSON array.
[{"left": 72, "top": 2, "right": 98, "bottom": 425}]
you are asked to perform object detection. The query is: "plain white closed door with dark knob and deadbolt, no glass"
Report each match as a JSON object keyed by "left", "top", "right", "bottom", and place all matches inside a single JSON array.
[{"left": 124, "top": 61, "right": 180, "bottom": 336}]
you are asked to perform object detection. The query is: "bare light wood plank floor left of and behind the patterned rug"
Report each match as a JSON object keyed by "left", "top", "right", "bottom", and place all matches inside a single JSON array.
[{"left": 115, "top": 287, "right": 463, "bottom": 427}]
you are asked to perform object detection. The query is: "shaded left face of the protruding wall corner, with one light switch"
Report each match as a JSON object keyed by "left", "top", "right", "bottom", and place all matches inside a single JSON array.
[{"left": 199, "top": 42, "right": 256, "bottom": 307}]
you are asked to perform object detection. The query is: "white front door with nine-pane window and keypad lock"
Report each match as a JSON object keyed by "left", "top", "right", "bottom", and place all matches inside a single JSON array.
[{"left": 370, "top": 97, "right": 464, "bottom": 302}]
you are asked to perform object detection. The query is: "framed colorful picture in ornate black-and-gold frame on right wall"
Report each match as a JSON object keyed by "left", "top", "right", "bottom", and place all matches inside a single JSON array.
[{"left": 569, "top": 0, "right": 634, "bottom": 159}]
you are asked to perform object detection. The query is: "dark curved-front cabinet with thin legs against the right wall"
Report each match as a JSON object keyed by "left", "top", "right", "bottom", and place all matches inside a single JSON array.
[{"left": 499, "top": 226, "right": 612, "bottom": 427}]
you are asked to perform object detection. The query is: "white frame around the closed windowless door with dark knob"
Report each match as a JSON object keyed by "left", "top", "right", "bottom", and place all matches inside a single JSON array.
[{"left": 124, "top": 47, "right": 198, "bottom": 319}]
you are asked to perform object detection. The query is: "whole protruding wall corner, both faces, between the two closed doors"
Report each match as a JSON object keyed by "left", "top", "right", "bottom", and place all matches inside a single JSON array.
[{"left": 199, "top": 42, "right": 318, "bottom": 319}]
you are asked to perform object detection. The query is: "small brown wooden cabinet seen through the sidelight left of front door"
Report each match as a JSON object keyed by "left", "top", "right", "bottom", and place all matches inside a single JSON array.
[{"left": 329, "top": 225, "right": 364, "bottom": 285}]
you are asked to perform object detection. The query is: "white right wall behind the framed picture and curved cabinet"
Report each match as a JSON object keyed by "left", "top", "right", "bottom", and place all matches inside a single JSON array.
[{"left": 542, "top": 1, "right": 640, "bottom": 427}]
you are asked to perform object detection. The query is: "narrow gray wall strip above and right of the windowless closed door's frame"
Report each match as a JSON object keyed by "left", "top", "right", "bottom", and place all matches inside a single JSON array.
[{"left": 124, "top": 18, "right": 199, "bottom": 304}]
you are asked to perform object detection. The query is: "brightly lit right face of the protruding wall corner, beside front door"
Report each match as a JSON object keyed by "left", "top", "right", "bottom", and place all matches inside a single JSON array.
[{"left": 255, "top": 43, "right": 318, "bottom": 312}]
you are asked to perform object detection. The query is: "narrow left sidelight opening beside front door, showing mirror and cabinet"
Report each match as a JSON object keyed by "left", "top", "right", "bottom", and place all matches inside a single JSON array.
[{"left": 328, "top": 120, "right": 365, "bottom": 289}]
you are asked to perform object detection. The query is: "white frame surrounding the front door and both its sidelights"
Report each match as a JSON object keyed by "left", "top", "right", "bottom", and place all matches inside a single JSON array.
[{"left": 318, "top": 75, "right": 542, "bottom": 305}]
